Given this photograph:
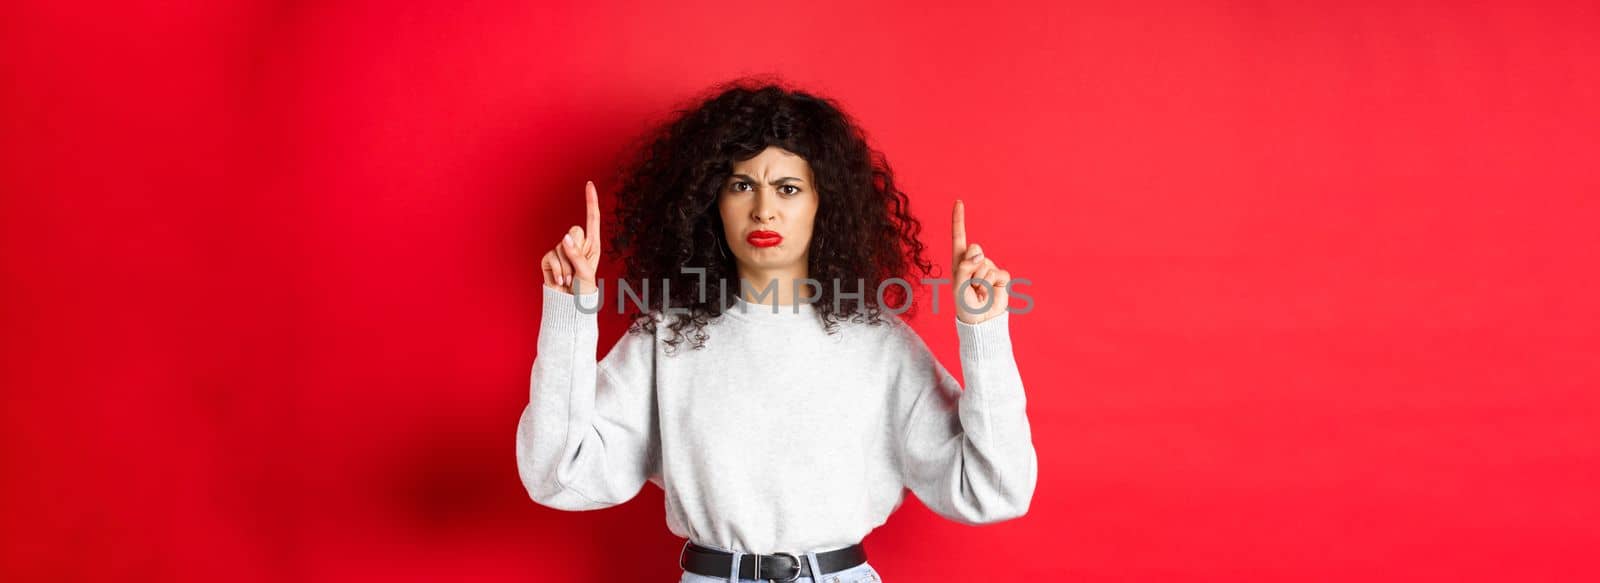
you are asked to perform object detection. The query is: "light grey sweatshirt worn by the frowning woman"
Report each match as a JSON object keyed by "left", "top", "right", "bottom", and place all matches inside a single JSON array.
[{"left": 517, "top": 287, "right": 1038, "bottom": 554}]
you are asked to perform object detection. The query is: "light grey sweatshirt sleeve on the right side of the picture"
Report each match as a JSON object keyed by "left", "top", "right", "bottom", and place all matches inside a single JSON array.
[{"left": 896, "top": 312, "right": 1038, "bottom": 525}]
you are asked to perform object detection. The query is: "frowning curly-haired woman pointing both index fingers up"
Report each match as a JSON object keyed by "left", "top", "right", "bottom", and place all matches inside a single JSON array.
[{"left": 517, "top": 82, "right": 1038, "bottom": 583}]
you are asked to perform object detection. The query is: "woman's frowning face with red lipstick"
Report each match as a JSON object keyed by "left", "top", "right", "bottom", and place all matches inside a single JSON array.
[{"left": 717, "top": 146, "right": 818, "bottom": 277}]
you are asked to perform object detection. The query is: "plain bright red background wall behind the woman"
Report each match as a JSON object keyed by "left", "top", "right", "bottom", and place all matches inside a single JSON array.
[{"left": 0, "top": 2, "right": 1600, "bottom": 583}]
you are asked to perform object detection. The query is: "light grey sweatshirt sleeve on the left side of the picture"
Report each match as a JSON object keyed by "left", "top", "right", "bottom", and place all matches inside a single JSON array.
[{"left": 517, "top": 287, "right": 661, "bottom": 511}]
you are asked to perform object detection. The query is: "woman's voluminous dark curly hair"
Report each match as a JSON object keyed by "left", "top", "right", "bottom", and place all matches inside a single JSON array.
[{"left": 611, "top": 78, "right": 933, "bottom": 352}]
